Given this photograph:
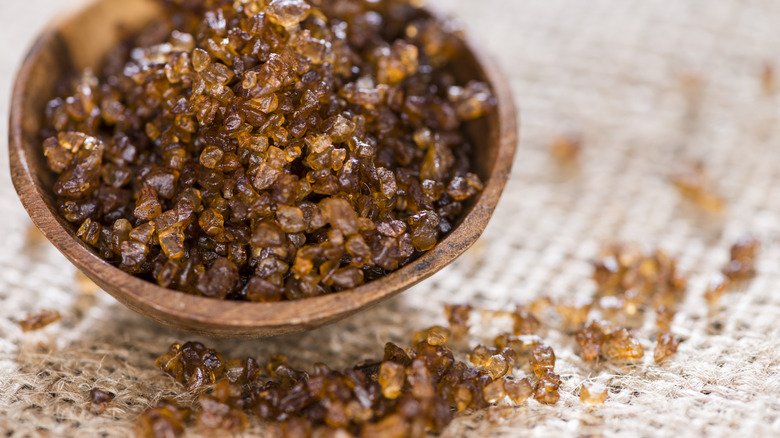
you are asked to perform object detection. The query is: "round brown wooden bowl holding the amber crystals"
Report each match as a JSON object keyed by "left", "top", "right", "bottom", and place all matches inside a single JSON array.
[{"left": 9, "top": 0, "right": 517, "bottom": 337}]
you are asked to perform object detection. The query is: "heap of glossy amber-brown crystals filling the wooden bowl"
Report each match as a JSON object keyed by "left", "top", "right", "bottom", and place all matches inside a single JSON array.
[{"left": 41, "top": 0, "right": 496, "bottom": 300}]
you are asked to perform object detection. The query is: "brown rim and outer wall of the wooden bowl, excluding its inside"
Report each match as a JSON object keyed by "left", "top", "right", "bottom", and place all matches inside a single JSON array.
[{"left": 9, "top": 0, "right": 518, "bottom": 337}]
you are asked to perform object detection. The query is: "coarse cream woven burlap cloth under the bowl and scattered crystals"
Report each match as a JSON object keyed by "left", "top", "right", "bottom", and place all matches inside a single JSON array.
[{"left": 0, "top": 0, "right": 780, "bottom": 437}]
